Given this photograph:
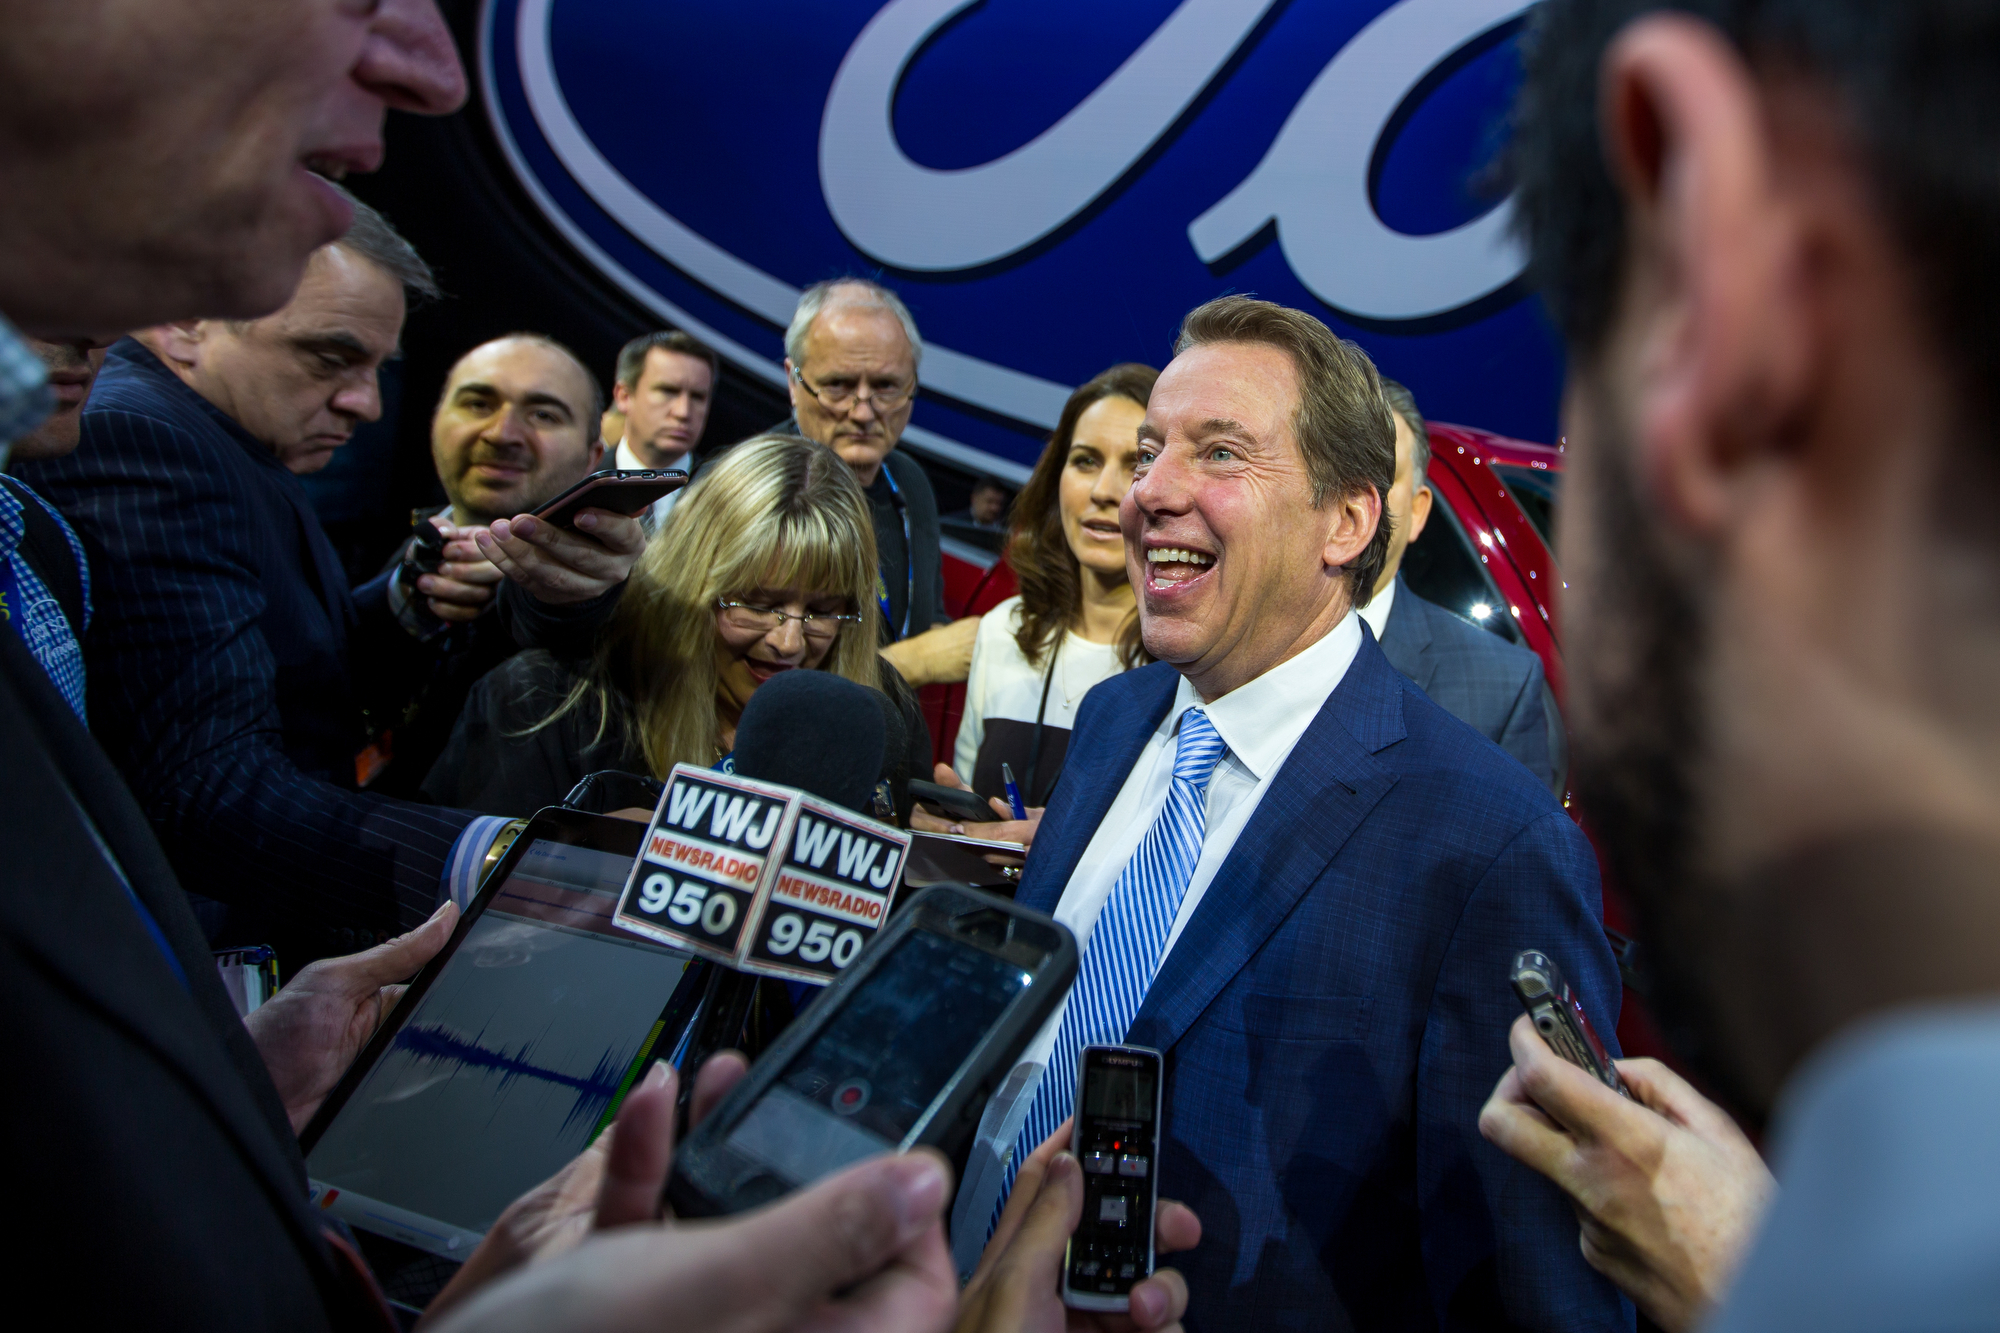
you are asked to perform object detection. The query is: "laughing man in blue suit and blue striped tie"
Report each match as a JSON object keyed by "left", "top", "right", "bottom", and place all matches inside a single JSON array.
[{"left": 956, "top": 296, "right": 1632, "bottom": 1331}]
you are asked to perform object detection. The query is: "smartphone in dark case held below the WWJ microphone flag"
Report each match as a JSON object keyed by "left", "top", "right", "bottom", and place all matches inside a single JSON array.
[{"left": 666, "top": 885, "right": 1076, "bottom": 1217}]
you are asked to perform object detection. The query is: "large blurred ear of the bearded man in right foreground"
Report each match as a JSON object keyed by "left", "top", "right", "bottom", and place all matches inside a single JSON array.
[{"left": 1600, "top": 14, "right": 1816, "bottom": 532}]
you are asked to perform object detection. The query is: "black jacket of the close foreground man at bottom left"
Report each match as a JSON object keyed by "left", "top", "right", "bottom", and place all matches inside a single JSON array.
[{"left": 0, "top": 608, "right": 384, "bottom": 1333}]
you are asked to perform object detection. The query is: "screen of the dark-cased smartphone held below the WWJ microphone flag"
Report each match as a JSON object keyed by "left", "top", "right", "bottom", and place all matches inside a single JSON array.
[{"left": 726, "top": 931, "right": 1034, "bottom": 1185}]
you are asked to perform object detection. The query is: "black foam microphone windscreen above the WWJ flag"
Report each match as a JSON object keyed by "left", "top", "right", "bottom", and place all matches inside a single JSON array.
[{"left": 736, "top": 669, "right": 884, "bottom": 815}]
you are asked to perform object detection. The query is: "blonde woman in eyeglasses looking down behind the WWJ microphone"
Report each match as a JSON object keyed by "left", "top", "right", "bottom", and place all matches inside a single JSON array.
[{"left": 424, "top": 434, "right": 930, "bottom": 815}]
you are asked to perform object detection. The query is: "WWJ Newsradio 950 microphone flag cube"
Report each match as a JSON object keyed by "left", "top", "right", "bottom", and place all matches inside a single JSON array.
[{"left": 614, "top": 765, "right": 910, "bottom": 983}]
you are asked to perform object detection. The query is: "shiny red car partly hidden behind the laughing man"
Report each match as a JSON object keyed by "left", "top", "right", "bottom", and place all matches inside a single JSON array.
[{"left": 924, "top": 422, "right": 1664, "bottom": 1057}]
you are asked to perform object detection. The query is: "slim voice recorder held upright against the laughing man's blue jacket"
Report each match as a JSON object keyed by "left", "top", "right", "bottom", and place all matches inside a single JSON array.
[{"left": 1062, "top": 1047, "right": 1162, "bottom": 1311}]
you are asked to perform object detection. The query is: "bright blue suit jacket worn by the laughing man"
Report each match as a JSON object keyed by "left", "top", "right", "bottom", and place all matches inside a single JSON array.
[{"left": 1018, "top": 632, "right": 1632, "bottom": 1333}]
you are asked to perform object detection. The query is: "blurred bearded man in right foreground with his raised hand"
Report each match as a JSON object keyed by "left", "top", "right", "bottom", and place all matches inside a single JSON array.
[{"left": 1482, "top": 0, "right": 2000, "bottom": 1333}]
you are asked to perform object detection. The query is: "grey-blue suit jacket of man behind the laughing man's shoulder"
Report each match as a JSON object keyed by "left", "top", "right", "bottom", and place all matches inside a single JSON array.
[{"left": 1382, "top": 574, "right": 1570, "bottom": 795}]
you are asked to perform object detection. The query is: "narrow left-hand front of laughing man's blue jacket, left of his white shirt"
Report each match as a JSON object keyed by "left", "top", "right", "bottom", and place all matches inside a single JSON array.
[{"left": 1014, "top": 662, "right": 1180, "bottom": 913}]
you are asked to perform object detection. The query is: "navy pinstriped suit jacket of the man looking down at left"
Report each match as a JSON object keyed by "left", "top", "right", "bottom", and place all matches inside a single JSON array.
[{"left": 20, "top": 338, "right": 472, "bottom": 931}]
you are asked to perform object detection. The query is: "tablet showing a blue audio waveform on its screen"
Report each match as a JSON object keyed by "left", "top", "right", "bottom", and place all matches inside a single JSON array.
[{"left": 300, "top": 809, "right": 696, "bottom": 1259}]
